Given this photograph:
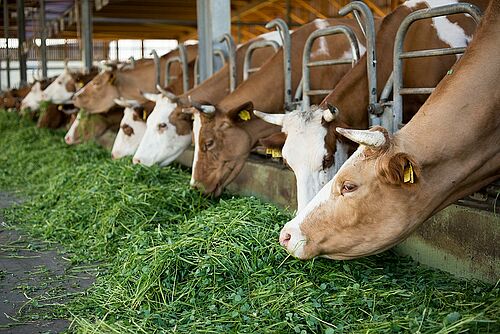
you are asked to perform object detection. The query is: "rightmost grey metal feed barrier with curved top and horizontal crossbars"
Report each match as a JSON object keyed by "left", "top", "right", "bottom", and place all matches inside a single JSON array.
[{"left": 382, "top": 3, "right": 481, "bottom": 132}]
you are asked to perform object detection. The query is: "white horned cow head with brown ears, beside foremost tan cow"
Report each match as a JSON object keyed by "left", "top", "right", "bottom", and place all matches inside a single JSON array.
[{"left": 254, "top": 107, "right": 348, "bottom": 211}]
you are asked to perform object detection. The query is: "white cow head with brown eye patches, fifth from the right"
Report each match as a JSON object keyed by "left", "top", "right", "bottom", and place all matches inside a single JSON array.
[{"left": 111, "top": 99, "right": 147, "bottom": 159}]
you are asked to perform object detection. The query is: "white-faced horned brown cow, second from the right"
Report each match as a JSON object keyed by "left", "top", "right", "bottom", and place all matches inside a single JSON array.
[{"left": 256, "top": 0, "right": 488, "bottom": 210}]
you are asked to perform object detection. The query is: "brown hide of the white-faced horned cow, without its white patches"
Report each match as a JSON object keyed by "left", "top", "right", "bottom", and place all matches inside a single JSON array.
[{"left": 321, "top": 0, "right": 485, "bottom": 171}]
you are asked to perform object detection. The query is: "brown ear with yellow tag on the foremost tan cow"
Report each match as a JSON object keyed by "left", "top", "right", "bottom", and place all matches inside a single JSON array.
[{"left": 376, "top": 152, "right": 420, "bottom": 185}]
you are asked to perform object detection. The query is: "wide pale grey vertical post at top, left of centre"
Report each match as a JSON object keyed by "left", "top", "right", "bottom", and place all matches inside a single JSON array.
[{"left": 196, "top": 0, "right": 231, "bottom": 82}]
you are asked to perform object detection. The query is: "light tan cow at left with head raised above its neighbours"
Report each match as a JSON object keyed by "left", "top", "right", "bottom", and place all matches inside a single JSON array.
[{"left": 74, "top": 45, "right": 198, "bottom": 113}]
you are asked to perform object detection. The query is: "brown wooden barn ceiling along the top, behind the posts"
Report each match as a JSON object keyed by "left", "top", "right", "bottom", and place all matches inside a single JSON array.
[{"left": 0, "top": 0, "right": 400, "bottom": 41}]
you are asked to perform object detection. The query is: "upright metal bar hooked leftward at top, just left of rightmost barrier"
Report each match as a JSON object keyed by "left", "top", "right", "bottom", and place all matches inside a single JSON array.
[{"left": 339, "top": 1, "right": 377, "bottom": 125}]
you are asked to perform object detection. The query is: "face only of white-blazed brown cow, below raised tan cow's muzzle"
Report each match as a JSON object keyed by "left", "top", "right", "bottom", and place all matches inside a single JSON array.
[{"left": 64, "top": 111, "right": 109, "bottom": 145}]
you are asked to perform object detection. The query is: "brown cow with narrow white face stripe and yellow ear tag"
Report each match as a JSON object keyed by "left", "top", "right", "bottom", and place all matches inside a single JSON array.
[{"left": 191, "top": 19, "right": 365, "bottom": 196}]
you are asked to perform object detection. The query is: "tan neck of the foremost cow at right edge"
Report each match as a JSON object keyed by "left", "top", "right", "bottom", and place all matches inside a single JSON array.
[{"left": 395, "top": 2, "right": 500, "bottom": 216}]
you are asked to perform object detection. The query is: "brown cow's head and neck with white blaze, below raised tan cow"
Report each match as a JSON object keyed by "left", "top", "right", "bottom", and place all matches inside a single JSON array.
[{"left": 64, "top": 107, "right": 123, "bottom": 149}]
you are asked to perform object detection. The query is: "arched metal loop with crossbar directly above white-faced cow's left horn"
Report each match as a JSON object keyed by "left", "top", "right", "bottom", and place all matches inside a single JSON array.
[{"left": 302, "top": 25, "right": 359, "bottom": 110}]
